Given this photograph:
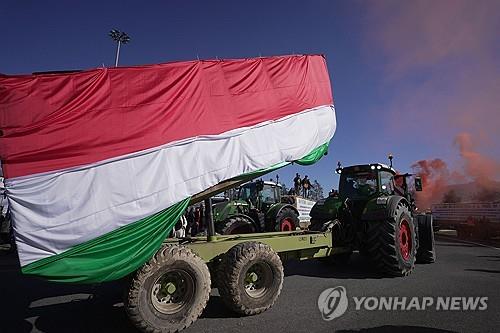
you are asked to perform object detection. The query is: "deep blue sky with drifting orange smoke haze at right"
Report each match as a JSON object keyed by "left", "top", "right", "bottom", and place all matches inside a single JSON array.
[{"left": 0, "top": 0, "right": 500, "bottom": 189}]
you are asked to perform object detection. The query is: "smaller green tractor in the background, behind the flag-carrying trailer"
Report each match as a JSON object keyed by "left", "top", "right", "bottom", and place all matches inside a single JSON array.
[{"left": 213, "top": 180, "right": 299, "bottom": 235}]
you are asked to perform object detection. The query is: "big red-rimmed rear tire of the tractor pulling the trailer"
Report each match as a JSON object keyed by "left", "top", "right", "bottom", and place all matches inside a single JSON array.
[{"left": 366, "top": 203, "right": 417, "bottom": 276}]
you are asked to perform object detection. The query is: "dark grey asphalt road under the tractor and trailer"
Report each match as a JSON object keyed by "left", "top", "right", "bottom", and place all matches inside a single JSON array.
[{"left": 0, "top": 238, "right": 500, "bottom": 333}]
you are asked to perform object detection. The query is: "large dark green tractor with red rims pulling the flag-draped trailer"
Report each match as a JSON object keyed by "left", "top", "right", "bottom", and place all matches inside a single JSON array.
[{"left": 310, "top": 156, "right": 435, "bottom": 276}]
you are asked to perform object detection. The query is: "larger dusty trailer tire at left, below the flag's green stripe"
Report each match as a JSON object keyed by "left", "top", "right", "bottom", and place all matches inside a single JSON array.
[{"left": 125, "top": 245, "right": 210, "bottom": 333}]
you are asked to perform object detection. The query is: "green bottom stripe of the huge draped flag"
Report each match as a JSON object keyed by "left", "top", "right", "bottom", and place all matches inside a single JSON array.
[{"left": 22, "top": 143, "right": 328, "bottom": 283}]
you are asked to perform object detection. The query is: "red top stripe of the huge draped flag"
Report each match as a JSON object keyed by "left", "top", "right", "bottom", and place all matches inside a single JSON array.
[{"left": 0, "top": 56, "right": 333, "bottom": 178}]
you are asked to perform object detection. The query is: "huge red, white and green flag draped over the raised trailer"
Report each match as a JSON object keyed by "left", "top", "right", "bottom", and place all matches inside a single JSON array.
[{"left": 0, "top": 55, "right": 336, "bottom": 282}]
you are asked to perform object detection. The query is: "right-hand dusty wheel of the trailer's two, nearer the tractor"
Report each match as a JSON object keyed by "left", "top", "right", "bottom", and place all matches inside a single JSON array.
[{"left": 217, "top": 242, "right": 283, "bottom": 316}]
